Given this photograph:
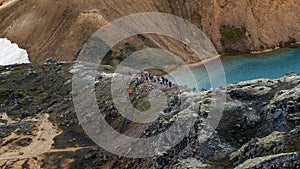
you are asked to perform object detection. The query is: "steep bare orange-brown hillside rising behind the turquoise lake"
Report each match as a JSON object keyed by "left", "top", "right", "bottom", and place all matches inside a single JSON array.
[{"left": 0, "top": 0, "right": 300, "bottom": 63}]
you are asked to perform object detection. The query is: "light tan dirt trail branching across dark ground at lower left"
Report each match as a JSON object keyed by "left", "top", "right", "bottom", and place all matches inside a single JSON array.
[{"left": 0, "top": 114, "right": 89, "bottom": 164}]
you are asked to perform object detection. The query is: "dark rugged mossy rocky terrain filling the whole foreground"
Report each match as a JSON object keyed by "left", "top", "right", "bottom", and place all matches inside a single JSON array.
[{"left": 0, "top": 59, "right": 300, "bottom": 169}]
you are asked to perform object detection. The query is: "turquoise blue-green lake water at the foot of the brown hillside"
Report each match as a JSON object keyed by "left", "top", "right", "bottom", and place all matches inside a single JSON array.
[{"left": 175, "top": 47, "right": 300, "bottom": 90}]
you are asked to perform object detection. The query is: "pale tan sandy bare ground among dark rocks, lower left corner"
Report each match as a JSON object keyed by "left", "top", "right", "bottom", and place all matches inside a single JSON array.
[{"left": 0, "top": 113, "right": 89, "bottom": 169}]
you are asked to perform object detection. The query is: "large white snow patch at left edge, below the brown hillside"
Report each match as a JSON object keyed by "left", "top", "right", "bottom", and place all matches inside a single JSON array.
[{"left": 0, "top": 38, "right": 30, "bottom": 66}]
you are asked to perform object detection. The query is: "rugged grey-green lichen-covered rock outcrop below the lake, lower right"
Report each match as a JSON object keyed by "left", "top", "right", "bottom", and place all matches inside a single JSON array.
[{"left": 150, "top": 75, "right": 300, "bottom": 169}]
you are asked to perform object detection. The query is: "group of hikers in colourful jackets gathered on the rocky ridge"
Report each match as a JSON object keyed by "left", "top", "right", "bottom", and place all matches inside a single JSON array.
[{"left": 134, "top": 70, "right": 173, "bottom": 87}]
